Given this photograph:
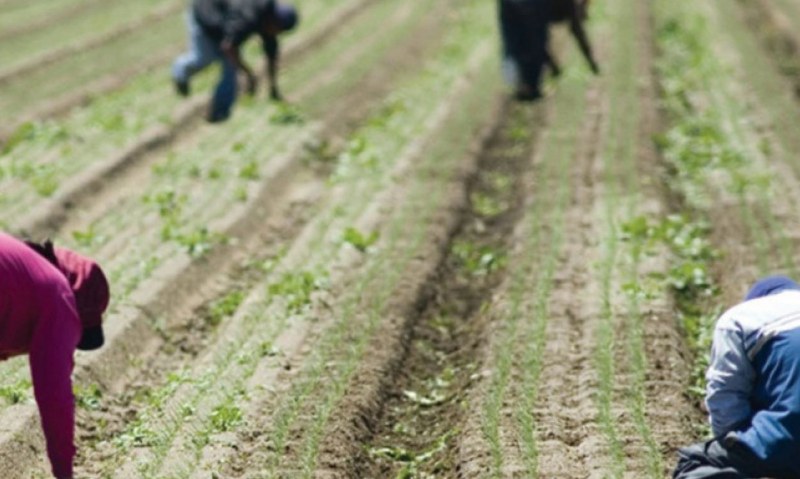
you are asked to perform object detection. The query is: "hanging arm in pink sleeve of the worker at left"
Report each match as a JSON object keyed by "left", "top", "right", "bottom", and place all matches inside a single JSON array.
[{"left": 29, "top": 287, "right": 81, "bottom": 479}]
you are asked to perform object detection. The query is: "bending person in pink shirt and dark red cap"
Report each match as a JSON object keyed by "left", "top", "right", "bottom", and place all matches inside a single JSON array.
[{"left": 0, "top": 233, "right": 109, "bottom": 479}]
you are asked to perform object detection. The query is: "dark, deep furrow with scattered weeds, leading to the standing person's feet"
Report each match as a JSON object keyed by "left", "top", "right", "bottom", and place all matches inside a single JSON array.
[{"left": 341, "top": 104, "right": 541, "bottom": 477}]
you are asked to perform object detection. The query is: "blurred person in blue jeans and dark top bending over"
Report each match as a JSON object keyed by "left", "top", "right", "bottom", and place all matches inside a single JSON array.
[{"left": 172, "top": 0, "right": 298, "bottom": 122}]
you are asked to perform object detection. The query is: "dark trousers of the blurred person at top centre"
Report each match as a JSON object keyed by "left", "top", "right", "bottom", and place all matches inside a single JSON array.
[{"left": 500, "top": 0, "right": 551, "bottom": 92}]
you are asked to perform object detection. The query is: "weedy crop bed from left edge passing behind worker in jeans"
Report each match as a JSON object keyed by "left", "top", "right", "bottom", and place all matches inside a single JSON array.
[{"left": 0, "top": 2, "right": 363, "bottom": 229}]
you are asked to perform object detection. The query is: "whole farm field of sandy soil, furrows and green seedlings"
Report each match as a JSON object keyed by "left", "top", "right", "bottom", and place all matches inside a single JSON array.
[{"left": 0, "top": 0, "right": 800, "bottom": 479}]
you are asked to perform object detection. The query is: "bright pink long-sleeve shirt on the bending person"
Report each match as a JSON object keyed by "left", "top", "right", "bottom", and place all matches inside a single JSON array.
[{"left": 0, "top": 233, "right": 81, "bottom": 478}]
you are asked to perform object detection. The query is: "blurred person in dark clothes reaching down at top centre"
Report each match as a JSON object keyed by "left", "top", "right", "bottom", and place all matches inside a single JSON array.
[{"left": 499, "top": 0, "right": 600, "bottom": 101}]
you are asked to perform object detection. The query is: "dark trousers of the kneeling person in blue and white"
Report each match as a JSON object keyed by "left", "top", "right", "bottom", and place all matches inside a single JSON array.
[{"left": 672, "top": 440, "right": 793, "bottom": 479}]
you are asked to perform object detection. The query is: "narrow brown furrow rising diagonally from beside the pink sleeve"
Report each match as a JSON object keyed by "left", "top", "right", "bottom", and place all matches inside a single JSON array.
[{"left": 54, "top": 4, "right": 456, "bottom": 477}]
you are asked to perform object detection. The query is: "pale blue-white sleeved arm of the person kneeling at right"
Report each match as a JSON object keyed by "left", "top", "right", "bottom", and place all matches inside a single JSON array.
[{"left": 706, "top": 326, "right": 756, "bottom": 437}]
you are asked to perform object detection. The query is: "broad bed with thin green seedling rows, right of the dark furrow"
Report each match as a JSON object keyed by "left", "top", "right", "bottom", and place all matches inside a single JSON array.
[{"left": 460, "top": 2, "right": 692, "bottom": 477}]
